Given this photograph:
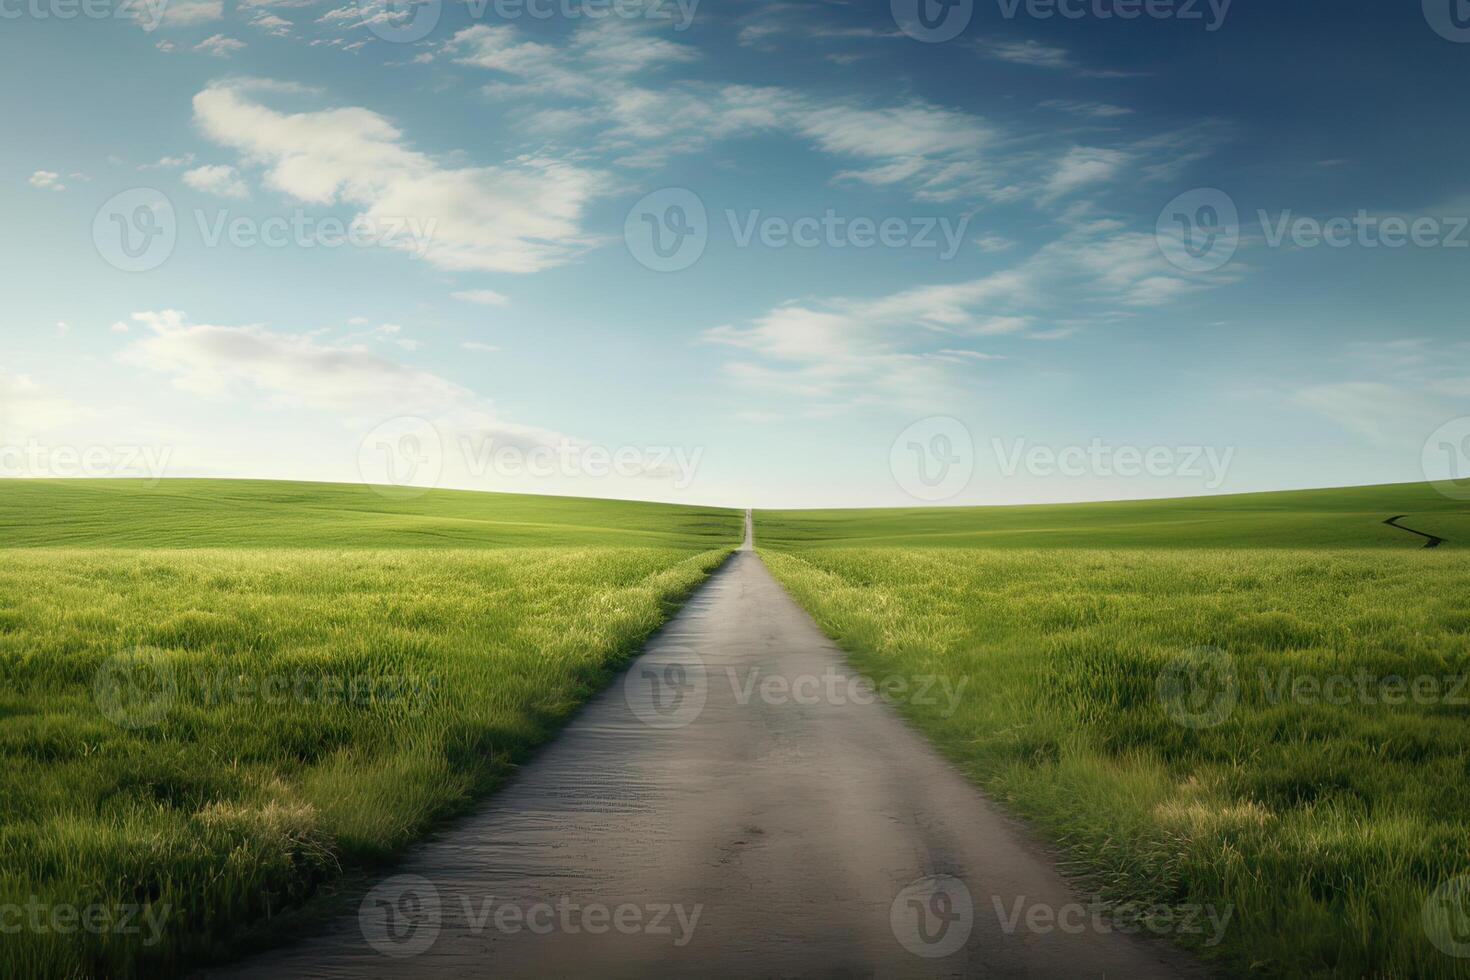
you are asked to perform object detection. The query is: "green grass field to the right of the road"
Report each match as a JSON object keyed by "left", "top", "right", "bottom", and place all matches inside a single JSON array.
[{"left": 756, "top": 485, "right": 1470, "bottom": 977}]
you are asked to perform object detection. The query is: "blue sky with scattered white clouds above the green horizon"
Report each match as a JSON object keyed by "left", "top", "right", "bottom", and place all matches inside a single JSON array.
[{"left": 0, "top": 0, "right": 1470, "bottom": 505}]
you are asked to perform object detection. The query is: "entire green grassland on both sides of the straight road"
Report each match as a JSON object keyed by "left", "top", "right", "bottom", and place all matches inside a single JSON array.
[{"left": 0, "top": 480, "right": 1470, "bottom": 977}]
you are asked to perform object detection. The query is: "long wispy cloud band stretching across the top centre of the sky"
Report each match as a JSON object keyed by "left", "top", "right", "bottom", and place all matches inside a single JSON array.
[{"left": 432, "top": 15, "right": 1217, "bottom": 206}]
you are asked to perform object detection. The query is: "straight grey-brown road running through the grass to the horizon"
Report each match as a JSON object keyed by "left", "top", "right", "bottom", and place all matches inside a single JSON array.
[{"left": 222, "top": 516, "right": 1198, "bottom": 980}]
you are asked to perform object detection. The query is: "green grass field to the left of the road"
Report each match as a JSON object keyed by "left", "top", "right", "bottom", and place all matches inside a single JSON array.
[{"left": 0, "top": 480, "right": 741, "bottom": 976}]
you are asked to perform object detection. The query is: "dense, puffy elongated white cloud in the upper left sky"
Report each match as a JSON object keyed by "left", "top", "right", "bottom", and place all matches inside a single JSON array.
[{"left": 194, "top": 82, "right": 603, "bottom": 272}]
